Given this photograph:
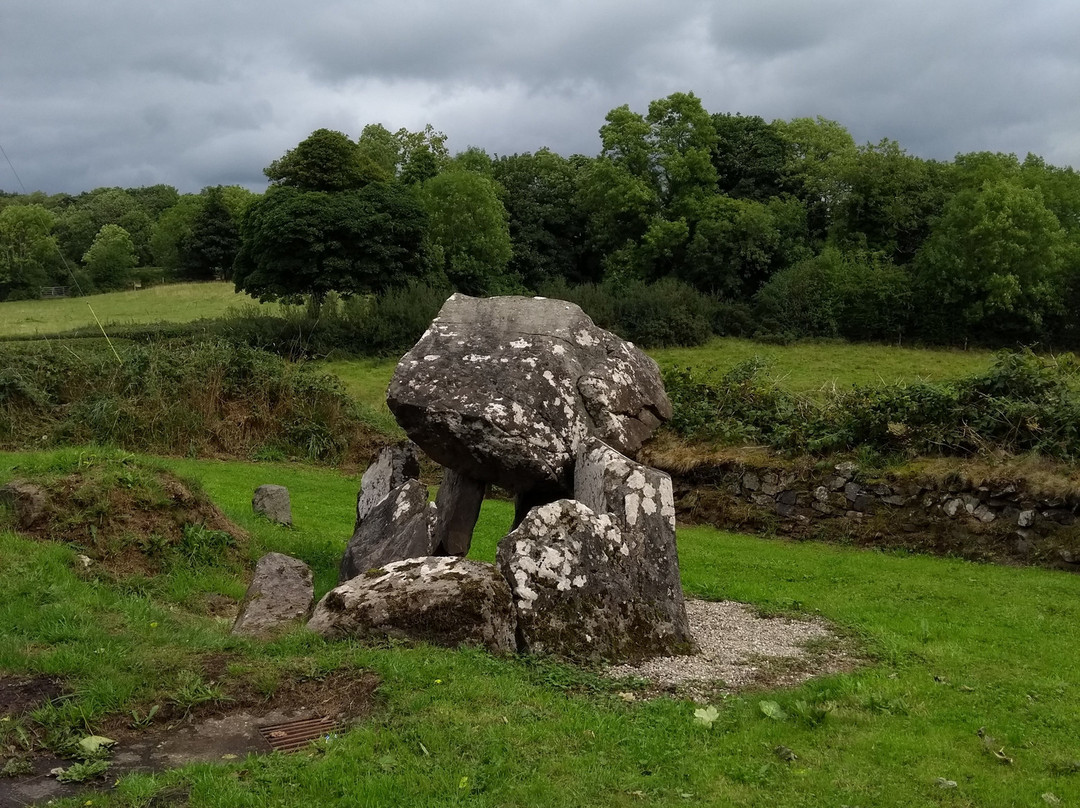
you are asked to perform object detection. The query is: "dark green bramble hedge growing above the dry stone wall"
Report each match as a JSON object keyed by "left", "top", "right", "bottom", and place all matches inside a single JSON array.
[{"left": 664, "top": 351, "right": 1080, "bottom": 461}]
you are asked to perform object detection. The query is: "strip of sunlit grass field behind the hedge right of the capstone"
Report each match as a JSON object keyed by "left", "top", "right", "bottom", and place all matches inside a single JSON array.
[{"left": 649, "top": 337, "right": 994, "bottom": 394}]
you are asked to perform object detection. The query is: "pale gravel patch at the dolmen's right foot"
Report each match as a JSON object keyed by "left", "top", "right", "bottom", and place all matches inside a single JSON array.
[{"left": 606, "top": 600, "right": 852, "bottom": 697}]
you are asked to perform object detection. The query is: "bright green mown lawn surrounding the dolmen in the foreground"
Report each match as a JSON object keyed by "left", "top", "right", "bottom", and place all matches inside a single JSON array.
[{"left": 0, "top": 450, "right": 1080, "bottom": 808}]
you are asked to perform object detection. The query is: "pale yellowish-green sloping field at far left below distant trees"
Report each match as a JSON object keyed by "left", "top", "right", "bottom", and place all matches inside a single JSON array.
[{"left": 0, "top": 282, "right": 274, "bottom": 337}]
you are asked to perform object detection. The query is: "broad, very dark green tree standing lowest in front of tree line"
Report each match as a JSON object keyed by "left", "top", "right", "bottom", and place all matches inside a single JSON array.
[{"left": 233, "top": 183, "right": 427, "bottom": 300}]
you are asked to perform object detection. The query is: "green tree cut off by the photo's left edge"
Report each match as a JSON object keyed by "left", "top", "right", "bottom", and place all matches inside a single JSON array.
[{"left": 0, "top": 205, "right": 56, "bottom": 300}]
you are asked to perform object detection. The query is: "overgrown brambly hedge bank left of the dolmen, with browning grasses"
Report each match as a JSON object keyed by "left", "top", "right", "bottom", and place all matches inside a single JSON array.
[{"left": 0, "top": 340, "right": 380, "bottom": 460}]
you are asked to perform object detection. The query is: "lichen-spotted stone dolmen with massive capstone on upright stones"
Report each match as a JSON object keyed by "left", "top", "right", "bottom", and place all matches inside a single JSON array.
[{"left": 308, "top": 295, "right": 694, "bottom": 662}]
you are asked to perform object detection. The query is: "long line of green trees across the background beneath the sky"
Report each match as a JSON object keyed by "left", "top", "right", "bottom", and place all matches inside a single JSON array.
[{"left": 0, "top": 93, "right": 1080, "bottom": 346}]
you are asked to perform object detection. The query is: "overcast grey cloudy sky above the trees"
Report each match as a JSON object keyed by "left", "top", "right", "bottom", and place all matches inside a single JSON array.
[{"left": 0, "top": 0, "right": 1080, "bottom": 193}]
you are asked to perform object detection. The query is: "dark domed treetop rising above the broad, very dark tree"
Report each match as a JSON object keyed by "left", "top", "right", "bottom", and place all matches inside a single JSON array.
[{"left": 264, "top": 129, "right": 380, "bottom": 191}]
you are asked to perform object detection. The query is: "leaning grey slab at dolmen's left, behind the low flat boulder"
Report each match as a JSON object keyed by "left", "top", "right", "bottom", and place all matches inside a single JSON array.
[{"left": 338, "top": 480, "right": 437, "bottom": 581}]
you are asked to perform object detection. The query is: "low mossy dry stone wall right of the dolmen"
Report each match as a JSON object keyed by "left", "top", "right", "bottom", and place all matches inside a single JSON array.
[{"left": 651, "top": 459, "right": 1080, "bottom": 571}]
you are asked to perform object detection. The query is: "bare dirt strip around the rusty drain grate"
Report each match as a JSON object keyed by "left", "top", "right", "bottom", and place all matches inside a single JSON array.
[{"left": 0, "top": 669, "right": 378, "bottom": 808}]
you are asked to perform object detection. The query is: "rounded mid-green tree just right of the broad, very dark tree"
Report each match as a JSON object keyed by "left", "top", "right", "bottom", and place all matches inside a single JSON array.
[{"left": 421, "top": 170, "right": 513, "bottom": 295}]
